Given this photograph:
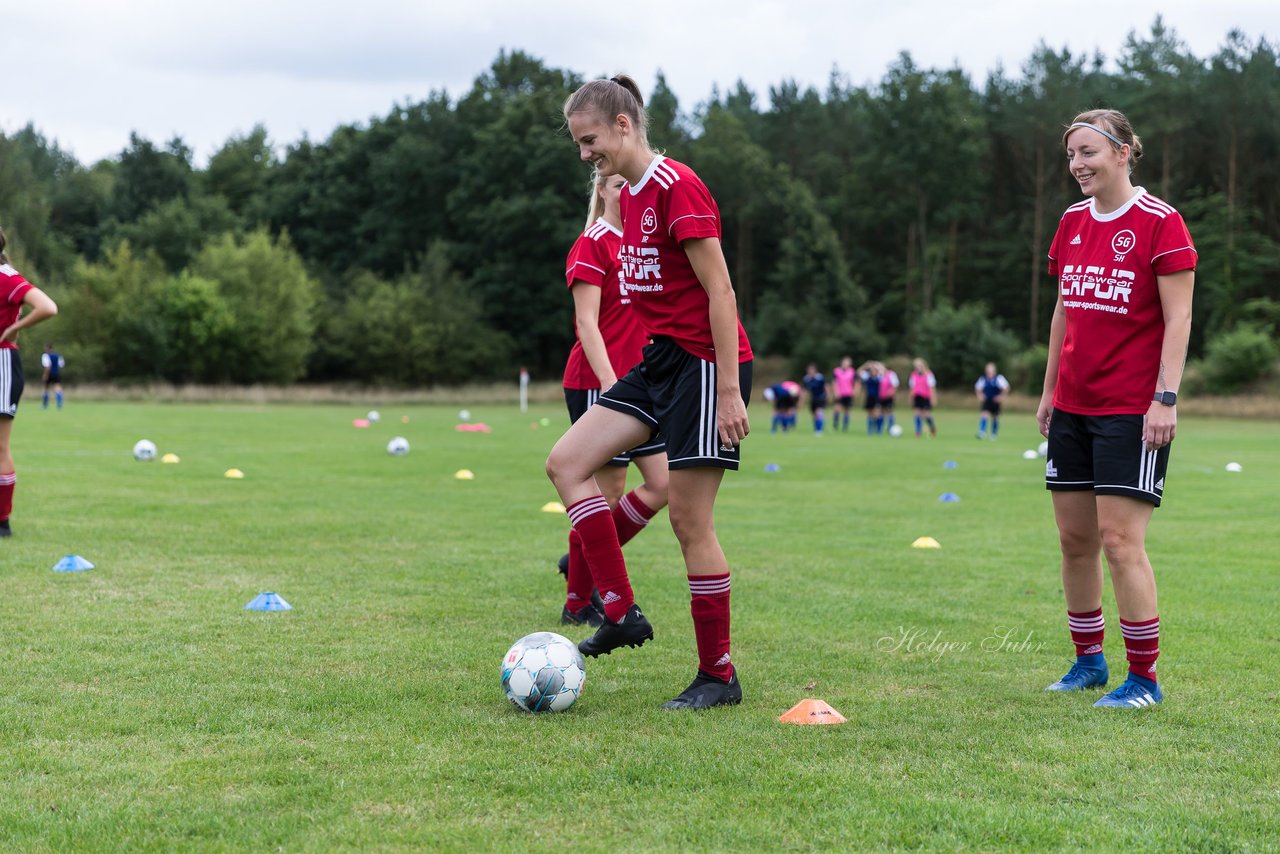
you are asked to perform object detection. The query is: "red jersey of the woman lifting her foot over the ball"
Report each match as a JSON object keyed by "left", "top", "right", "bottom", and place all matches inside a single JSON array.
[{"left": 620, "top": 155, "right": 751, "bottom": 362}]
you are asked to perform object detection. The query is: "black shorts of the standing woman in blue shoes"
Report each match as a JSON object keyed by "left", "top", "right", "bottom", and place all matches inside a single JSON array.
[{"left": 1044, "top": 410, "right": 1169, "bottom": 507}]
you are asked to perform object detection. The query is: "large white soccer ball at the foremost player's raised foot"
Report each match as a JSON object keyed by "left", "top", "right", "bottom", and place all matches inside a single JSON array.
[{"left": 502, "top": 631, "right": 586, "bottom": 712}]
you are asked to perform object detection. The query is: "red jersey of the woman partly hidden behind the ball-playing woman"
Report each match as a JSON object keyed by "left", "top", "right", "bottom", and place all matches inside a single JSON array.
[{"left": 564, "top": 219, "right": 649, "bottom": 389}]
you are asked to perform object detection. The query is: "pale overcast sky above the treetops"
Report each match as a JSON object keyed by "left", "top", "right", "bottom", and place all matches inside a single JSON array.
[{"left": 0, "top": 0, "right": 1280, "bottom": 164}]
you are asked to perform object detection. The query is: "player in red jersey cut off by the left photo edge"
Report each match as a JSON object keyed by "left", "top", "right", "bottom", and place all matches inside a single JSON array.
[{"left": 0, "top": 229, "right": 58, "bottom": 538}]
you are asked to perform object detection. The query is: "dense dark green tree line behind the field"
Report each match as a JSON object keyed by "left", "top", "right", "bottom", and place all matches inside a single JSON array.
[{"left": 0, "top": 18, "right": 1280, "bottom": 384}]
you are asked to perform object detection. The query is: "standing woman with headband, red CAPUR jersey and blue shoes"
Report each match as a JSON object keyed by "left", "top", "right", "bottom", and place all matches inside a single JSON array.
[{"left": 1036, "top": 110, "right": 1196, "bottom": 708}]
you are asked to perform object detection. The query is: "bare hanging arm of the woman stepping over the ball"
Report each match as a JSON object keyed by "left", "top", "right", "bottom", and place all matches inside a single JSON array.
[{"left": 684, "top": 237, "right": 751, "bottom": 446}]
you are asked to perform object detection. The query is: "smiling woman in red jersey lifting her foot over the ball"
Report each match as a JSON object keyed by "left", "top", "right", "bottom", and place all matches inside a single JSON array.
[{"left": 547, "top": 77, "right": 751, "bottom": 709}]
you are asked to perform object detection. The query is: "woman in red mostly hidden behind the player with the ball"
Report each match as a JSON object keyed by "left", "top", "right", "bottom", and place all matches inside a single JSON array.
[{"left": 561, "top": 174, "right": 667, "bottom": 626}]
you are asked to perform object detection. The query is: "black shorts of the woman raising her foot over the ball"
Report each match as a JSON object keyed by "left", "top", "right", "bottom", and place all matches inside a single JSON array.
[{"left": 599, "top": 335, "right": 751, "bottom": 471}]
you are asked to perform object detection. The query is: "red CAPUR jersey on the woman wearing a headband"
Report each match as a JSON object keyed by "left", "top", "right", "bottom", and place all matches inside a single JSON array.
[{"left": 1048, "top": 187, "right": 1197, "bottom": 415}]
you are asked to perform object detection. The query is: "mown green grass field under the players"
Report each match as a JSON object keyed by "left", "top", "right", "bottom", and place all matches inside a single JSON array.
[{"left": 0, "top": 401, "right": 1280, "bottom": 850}]
